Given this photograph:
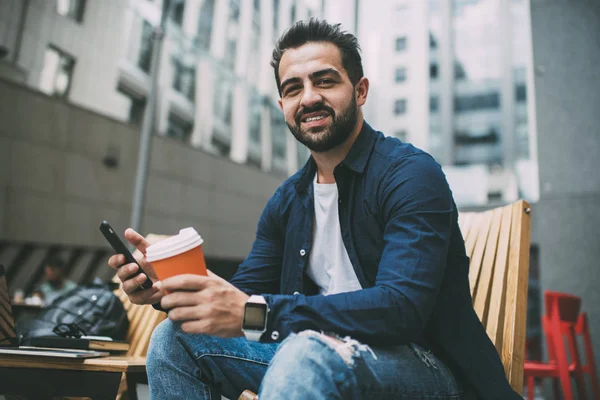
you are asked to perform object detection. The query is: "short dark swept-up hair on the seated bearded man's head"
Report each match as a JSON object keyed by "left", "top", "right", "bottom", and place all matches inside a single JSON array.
[{"left": 271, "top": 18, "right": 363, "bottom": 95}]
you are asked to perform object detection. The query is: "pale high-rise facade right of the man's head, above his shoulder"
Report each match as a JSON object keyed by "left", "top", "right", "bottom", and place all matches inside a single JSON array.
[{"left": 350, "top": 0, "right": 539, "bottom": 207}]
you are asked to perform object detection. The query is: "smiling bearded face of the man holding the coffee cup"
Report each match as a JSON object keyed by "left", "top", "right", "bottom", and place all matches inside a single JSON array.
[{"left": 279, "top": 43, "right": 362, "bottom": 152}]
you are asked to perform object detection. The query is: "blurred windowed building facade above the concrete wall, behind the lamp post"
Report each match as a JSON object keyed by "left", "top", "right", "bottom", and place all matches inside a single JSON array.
[{"left": 0, "top": 0, "right": 321, "bottom": 176}]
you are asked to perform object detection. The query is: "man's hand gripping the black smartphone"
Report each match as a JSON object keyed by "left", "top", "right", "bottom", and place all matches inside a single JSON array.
[{"left": 108, "top": 228, "right": 164, "bottom": 304}]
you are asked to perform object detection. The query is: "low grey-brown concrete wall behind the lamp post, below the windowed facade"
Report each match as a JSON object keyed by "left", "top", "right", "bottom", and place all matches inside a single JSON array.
[{"left": 0, "top": 80, "right": 282, "bottom": 259}]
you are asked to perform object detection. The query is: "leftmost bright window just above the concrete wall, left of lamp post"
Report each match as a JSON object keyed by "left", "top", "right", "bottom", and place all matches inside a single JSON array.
[{"left": 40, "top": 46, "right": 75, "bottom": 98}]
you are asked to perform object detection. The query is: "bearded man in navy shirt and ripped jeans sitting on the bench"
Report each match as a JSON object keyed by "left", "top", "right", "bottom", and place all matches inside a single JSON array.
[{"left": 110, "top": 20, "right": 520, "bottom": 400}]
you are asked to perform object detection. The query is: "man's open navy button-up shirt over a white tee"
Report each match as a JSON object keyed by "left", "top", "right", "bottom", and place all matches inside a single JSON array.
[{"left": 231, "top": 122, "right": 519, "bottom": 399}]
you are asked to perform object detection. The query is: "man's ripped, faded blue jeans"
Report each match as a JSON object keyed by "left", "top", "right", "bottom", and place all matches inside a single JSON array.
[{"left": 147, "top": 319, "right": 462, "bottom": 400}]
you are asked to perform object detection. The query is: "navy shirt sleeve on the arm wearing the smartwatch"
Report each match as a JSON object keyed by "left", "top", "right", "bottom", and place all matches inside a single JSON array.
[{"left": 263, "top": 154, "right": 454, "bottom": 343}]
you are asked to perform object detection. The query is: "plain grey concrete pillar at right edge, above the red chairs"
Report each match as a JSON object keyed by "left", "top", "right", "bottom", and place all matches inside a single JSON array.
[{"left": 531, "top": 0, "right": 600, "bottom": 372}]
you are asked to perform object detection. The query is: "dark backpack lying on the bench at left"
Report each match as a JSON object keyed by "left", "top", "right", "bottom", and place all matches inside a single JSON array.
[{"left": 16, "top": 280, "right": 129, "bottom": 346}]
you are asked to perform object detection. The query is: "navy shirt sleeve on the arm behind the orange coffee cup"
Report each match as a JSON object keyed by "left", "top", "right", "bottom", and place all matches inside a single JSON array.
[{"left": 230, "top": 189, "right": 284, "bottom": 295}]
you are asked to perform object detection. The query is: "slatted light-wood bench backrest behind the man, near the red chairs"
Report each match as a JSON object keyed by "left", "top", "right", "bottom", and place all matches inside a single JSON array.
[{"left": 459, "top": 200, "right": 531, "bottom": 393}]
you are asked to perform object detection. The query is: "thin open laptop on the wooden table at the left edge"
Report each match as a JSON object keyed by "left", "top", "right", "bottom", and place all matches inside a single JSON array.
[{"left": 0, "top": 264, "right": 110, "bottom": 358}]
